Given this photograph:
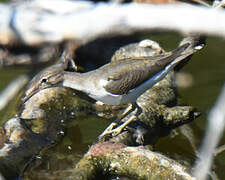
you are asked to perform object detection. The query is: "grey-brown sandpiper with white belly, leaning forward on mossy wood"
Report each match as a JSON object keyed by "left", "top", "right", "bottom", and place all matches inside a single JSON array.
[{"left": 23, "top": 41, "right": 202, "bottom": 137}]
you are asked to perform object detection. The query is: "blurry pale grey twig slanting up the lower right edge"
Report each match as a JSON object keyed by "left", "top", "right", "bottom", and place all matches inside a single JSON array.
[{"left": 193, "top": 85, "right": 225, "bottom": 180}]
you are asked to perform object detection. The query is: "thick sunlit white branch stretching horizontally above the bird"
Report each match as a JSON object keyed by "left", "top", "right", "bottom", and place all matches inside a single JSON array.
[{"left": 0, "top": 0, "right": 225, "bottom": 45}]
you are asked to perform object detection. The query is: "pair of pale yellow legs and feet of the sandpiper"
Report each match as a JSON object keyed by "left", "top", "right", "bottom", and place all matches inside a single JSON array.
[{"left": 99, "top": 103, "right": 142, "bottom": 139}]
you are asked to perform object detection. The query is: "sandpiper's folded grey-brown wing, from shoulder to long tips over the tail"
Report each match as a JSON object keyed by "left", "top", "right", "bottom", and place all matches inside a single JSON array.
[{"left": 104, "top": 45, "right": 195, "bottom": 95}]
